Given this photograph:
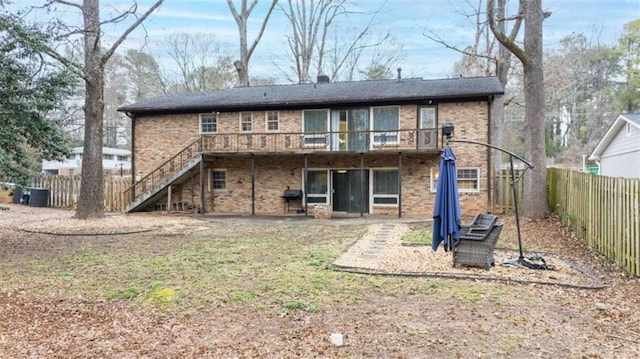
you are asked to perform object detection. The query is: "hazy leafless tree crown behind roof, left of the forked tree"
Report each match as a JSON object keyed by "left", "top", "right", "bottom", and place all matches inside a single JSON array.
[{"left": 164, "top": 33, "right": 234, "bottom": 92}]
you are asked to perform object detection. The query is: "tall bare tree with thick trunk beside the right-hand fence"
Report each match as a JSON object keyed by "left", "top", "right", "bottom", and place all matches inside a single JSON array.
[{"left": 487, "top": 0, "right": 551, "bottom": 218}]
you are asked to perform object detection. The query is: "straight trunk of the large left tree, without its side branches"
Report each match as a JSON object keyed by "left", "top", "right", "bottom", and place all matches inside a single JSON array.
[{"left": 76, "top": 0, "right": 104, "bottom": 219}]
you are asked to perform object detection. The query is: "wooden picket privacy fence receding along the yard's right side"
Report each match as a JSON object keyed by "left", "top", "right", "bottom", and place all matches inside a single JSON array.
[{"left": 547, "top": 168, "right": 640, "bottom": 276}]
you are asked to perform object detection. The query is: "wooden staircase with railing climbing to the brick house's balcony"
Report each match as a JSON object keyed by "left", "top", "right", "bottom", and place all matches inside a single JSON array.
[{"left": 124, "top": 137, "right": 204, "bottom": 213}]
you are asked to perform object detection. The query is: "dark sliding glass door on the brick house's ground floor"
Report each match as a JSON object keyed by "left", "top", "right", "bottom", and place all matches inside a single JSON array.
[{"left": 332, "top": 170, "right": 369, "bottom": 213}]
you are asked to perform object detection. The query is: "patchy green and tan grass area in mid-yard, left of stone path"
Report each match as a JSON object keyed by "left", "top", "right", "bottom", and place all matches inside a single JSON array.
[{"left": 0, "top": 226, "right": 512, "bottom": 313}]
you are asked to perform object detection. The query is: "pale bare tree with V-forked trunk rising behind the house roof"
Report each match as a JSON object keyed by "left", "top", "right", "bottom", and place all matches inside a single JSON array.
[{"left": 227, "top": 0, "right": 278, "bottom": 86}]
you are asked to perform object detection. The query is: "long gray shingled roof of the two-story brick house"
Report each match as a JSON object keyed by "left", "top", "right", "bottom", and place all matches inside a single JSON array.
[{"left": 118, "top": 77, "right": 504, "bottom": 114}]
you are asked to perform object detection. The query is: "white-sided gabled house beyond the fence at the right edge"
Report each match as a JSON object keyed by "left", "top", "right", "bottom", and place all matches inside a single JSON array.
[{"left": 589, "top": 113, "right": 640, "bottom": 178}]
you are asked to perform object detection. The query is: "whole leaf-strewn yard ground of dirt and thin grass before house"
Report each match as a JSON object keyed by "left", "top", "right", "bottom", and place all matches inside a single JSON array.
[{"left": 0, "top": 205, "right": 640, "bottom": 358}]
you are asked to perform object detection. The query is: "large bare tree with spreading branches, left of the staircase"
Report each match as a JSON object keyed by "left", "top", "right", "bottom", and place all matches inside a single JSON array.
[{"left": 19, "top": 0, "right": 164, "bottom": 219}]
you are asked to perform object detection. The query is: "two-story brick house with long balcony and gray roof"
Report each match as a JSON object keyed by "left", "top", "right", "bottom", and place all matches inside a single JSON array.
[{"left": 119, "top": 77, "right": 503, "bottom": 217}]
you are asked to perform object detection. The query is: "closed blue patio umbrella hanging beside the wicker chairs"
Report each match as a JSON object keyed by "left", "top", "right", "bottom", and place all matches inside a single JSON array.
[{"left": 431, "top": 146, "right": 460, "bottom": 251}]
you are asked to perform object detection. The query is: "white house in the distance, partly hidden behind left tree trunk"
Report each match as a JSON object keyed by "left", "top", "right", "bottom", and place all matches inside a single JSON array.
[{"left": 42, "top": 147, "right": 131, "bottom": 176}]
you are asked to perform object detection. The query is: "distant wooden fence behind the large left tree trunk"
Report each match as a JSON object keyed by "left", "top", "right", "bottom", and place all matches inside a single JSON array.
[{"left": 31, "top": 175, "right": 131, "bottom": 212}]
